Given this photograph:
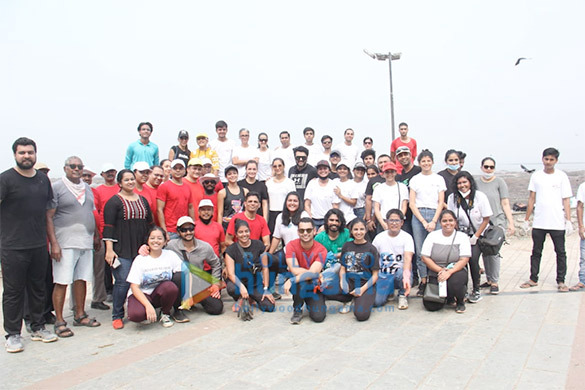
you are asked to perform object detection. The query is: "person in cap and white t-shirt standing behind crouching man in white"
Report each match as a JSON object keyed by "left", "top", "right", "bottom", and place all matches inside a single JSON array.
[{"left": 372, "top": 162, "right": 408, "bottom": 230}]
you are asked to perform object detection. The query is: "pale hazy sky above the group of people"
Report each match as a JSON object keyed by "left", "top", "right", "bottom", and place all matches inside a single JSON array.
[{"left": 0, "top": 0, "right": 585, "bottom": 177}]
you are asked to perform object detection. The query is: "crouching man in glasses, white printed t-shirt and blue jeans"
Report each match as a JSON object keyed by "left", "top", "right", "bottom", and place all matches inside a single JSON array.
[{"left": 372, "top": 208, "right": 414, "bottom": 310}]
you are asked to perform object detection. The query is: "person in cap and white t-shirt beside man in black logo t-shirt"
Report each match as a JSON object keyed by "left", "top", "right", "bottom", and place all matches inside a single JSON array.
[{"left": 305, "top": 160, "right": 339, "bottom": 230}]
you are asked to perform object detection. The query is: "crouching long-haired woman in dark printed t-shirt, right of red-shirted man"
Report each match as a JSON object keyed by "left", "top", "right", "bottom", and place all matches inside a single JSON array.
[{"left": 339, "top": 218, "right": 380, "bottom": 321}]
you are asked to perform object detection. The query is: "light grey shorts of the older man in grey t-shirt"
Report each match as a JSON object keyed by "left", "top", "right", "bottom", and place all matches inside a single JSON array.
[{"left": 53, "top": 249, "right": 93, "bottom": 286}]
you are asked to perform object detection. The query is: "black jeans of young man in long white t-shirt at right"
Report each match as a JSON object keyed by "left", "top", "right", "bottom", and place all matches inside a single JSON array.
[{"left": 530, "top": 229, "right": 567, "bottom": 283}]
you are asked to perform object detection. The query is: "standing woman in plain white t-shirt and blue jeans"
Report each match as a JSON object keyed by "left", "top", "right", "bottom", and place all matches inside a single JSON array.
[{"left": 409, "top": 149, "right": 447, "bottom": 297}]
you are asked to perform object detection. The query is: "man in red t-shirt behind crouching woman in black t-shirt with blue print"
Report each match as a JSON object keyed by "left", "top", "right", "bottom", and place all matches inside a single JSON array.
[{"left": 226, "top": 191, "right": 270, "bottom": 252}]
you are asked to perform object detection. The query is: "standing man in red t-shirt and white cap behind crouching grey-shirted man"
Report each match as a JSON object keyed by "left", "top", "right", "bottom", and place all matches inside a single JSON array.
[{"left": 156, "top": 159, "right": 195, "bottom": 238}]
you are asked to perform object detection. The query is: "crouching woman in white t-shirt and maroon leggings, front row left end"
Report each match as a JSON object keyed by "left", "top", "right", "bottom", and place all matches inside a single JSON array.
[{"left": 126, "top": 226, "right": 182, "bottom": 328}]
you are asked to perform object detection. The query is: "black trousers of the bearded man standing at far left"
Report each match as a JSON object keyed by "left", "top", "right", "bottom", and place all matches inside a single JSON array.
[{"left": 1, "top": 245, "right": 47, "bottom": 338}]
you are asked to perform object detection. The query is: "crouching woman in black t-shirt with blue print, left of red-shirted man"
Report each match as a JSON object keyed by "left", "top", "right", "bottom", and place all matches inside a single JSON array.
[{"left": 225, "top": 219, "right": 274, "bottom": 311}]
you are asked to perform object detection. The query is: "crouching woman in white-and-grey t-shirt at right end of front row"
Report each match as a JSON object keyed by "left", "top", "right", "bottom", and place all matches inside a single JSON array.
[{"left": 421, "top": 210, "right": 471, "bottom": 313}]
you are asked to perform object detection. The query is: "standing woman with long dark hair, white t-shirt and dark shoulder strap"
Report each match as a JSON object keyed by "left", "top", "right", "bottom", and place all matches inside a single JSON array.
[{"left": 447, "top": 171, "right": 493, "bottom": 303}]
